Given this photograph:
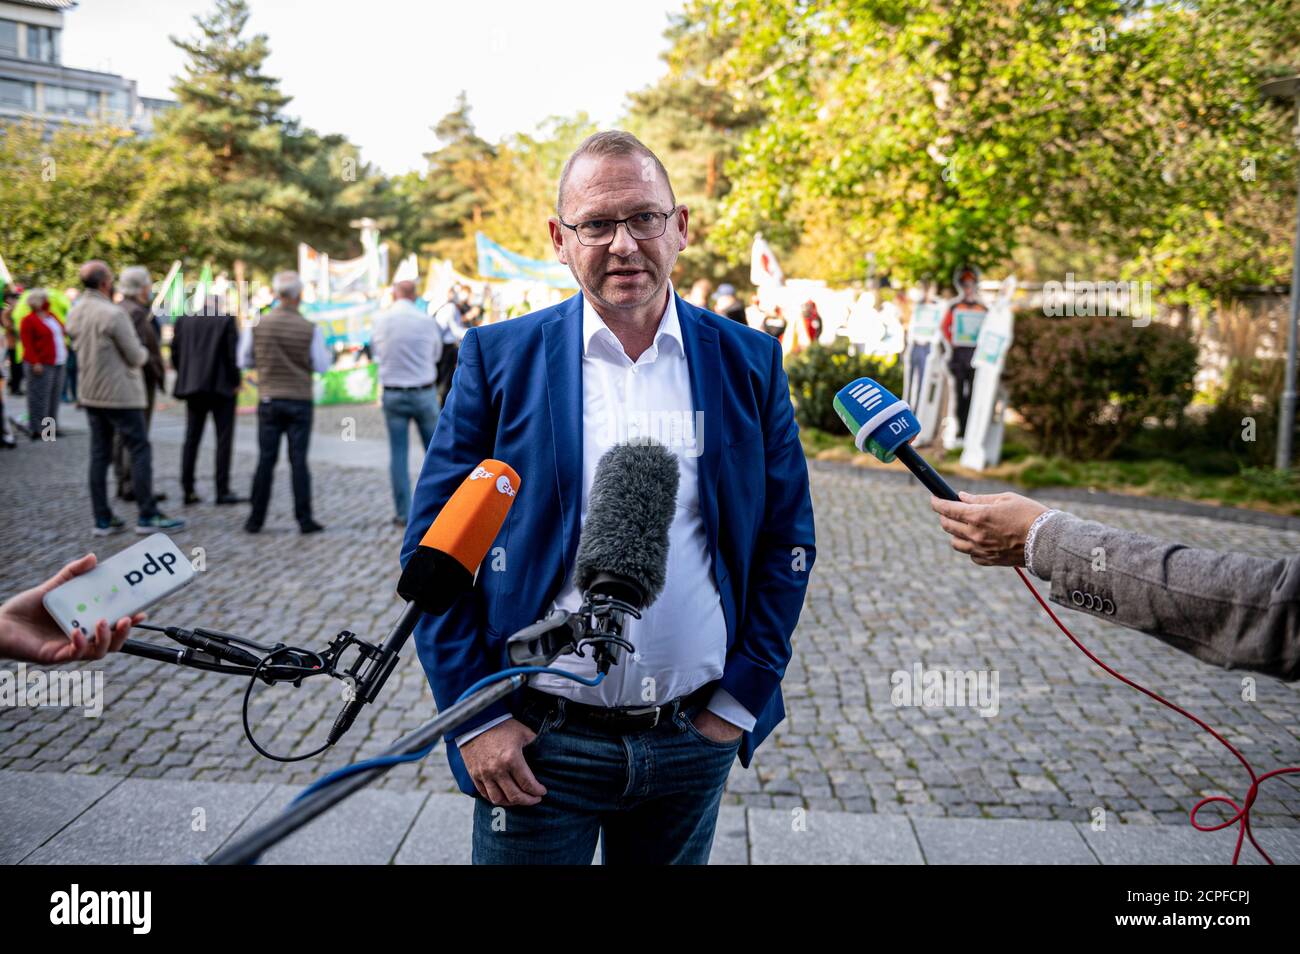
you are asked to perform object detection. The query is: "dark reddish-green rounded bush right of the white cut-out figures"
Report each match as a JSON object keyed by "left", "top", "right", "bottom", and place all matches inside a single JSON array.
[{"left": 1004, "top": 315, "right": 1196, "bottom": 460}]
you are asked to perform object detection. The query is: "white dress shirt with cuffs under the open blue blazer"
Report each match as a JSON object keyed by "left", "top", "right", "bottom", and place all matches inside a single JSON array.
[{"left": 456, "top": 283, "right": 755, "bottom": 745}]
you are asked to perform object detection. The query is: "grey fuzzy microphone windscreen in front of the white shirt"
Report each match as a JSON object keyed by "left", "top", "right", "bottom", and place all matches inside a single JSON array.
[{"left": 573, "top": 442, "right": 679, "bottom": 610}]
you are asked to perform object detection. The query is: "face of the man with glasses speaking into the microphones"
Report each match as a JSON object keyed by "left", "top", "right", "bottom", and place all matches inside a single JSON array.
[{"left": 550, "top": 156, "right": 688, "bottom": 309}]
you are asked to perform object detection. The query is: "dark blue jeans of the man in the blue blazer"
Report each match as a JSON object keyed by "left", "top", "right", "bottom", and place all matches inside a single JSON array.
[{"left": 473, "top": 697, "right": 741, "bottom": 864}]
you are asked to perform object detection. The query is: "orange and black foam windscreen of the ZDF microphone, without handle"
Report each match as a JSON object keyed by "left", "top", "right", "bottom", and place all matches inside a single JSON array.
[{"left": 398, "top": 460, "right": 520, "bottom": 615}]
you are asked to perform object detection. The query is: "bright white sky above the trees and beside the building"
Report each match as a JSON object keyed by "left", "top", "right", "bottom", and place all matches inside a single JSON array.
[{"left": 62, "top": 0, "right": 683, "bottom": 174}]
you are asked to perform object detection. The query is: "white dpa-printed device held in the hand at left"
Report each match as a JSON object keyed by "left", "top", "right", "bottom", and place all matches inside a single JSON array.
[{"left": 43, "top": 533, "right": 198, "bottom": 634}]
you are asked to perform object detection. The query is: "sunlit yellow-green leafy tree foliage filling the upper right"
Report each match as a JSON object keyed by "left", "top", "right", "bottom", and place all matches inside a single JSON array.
[{"left": 686, "top": 0, "right": 1300, "bottom": 295}]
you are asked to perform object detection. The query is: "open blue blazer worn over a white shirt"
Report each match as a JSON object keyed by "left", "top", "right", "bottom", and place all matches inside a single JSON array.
[{"left": 402, "top": 292, "right": 815, "bottom": 794}]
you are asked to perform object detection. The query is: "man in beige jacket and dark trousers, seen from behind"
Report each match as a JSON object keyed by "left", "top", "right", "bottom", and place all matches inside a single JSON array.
[{"left": 68, "top": 261, "right": 185, "bottom": 537}]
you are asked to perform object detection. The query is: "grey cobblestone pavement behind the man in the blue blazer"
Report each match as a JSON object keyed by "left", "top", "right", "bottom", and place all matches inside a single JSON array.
[{"left": 0, "top": 395, "right": 1300, "bottom": 827}]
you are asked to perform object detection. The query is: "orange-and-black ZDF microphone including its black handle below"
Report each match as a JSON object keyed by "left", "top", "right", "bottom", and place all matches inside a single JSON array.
[{"left": 326, "top": 460, "right": 519, "bottom": 745}]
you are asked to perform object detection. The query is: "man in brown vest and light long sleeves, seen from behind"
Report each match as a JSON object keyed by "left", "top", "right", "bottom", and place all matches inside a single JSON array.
[{"left": 238, "top": 272, "right": 332, "bottom": 533}]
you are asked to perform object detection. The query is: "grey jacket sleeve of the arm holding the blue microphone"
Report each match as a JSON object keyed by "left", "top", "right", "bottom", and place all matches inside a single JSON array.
[{"left": 1028, "top": 513, "right": 1300, "bottom": 680}]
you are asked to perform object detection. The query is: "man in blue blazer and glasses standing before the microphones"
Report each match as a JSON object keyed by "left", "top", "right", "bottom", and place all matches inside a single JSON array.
[{"left": 402, "top": 131, "right": 815, "bottom": 864}]
